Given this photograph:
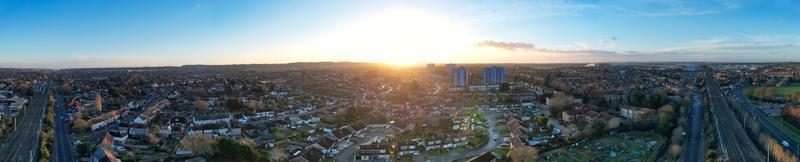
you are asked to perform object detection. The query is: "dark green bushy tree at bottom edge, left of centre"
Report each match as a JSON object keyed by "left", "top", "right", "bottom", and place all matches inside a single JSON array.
[{"left": 211, "top": 138, "right": 263, "bottom": 162}]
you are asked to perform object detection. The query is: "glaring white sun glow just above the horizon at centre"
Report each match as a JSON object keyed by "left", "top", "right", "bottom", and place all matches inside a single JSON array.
[{"left": 310, "top": 8, "right": 475, "bottom": 66}]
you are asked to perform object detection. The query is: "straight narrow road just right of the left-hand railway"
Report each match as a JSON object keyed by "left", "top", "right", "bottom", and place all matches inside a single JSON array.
[{"left": 52, "top": 94, "right": 78, "bottom": 162}]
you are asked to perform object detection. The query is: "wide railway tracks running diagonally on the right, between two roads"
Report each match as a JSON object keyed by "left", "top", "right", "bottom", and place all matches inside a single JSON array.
[{"left": 704, "top": 68, "right": 766, "bottom": 162}]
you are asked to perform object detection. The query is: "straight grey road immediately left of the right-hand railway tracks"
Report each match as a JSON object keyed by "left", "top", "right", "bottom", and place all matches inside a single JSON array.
[{"left": 680, "top": 92, "right": 706, "bottom": 162}]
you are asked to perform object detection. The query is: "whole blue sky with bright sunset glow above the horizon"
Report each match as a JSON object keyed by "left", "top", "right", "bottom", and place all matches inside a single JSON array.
[{"left": 0, "top": 0, "right": 800, "bottom": 68}]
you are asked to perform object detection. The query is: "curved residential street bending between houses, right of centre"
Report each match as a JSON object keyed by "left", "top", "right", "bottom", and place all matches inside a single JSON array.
[{"left": 425, "top": 110, "right": 503, "bottom": 161}]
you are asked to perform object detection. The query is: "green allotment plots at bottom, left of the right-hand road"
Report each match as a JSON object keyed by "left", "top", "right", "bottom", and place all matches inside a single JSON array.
[{"left": 540, "top": 133, "right": 664, "bottom": 161}]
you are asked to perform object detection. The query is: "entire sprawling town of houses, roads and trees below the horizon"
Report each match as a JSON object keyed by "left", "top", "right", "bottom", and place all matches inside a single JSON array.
[{"left": 0, "top": 62, "right": 800, "bottom": 161}]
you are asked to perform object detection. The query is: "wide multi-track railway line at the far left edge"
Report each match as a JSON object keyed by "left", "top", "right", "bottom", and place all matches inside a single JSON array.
[{"left": 0, "top": 77, "right": 52, "bottom": 162}]
